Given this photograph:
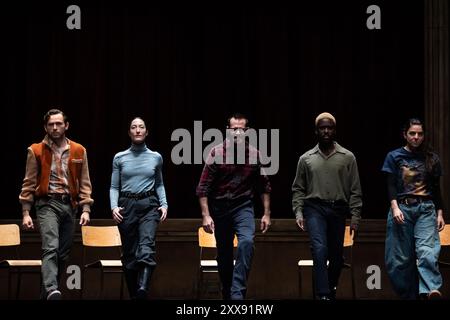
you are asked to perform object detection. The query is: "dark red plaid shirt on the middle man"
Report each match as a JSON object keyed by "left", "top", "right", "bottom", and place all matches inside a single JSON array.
[{"left": 197, "top": 140, "right": 271, "bottom": 200}]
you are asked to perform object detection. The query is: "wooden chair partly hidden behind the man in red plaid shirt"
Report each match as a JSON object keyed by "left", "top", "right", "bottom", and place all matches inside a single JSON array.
[{"left": 197, "top": 227, "right": 238, "bottom": 299}]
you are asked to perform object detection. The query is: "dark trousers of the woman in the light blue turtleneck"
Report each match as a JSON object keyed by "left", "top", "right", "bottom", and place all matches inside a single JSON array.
[{"left": 118, "top": 195, "right": 160, "bottom": 270}]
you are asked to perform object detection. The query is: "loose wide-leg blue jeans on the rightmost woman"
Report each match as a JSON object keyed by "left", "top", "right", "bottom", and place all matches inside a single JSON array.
[{"left": 385, "top": 201, "right": 442, "bottom": 299}]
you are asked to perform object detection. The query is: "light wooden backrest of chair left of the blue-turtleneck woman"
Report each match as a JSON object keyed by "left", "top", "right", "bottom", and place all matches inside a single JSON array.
[{"left": 81, "top": 226, "right": 122, "bottom": 247}]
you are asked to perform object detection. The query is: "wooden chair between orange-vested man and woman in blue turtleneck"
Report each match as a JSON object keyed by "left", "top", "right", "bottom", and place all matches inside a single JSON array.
[{"left": 80, "top": 226, "right": 123, "bottom": 299}]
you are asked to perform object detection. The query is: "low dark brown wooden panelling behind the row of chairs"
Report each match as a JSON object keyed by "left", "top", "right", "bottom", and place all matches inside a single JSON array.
[{"left": 0, "top": 219, "right": 450, "bottom": 299}]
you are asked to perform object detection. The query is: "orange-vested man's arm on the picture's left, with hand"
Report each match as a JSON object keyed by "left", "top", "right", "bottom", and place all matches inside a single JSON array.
[{"left": 19, "top": 148, "right": 39, "bottom": 230}]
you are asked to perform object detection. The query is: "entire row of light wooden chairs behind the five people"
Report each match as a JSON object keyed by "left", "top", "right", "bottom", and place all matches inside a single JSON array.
[{"left": 0, "top": 224, "right": 450, "bottom": 299}]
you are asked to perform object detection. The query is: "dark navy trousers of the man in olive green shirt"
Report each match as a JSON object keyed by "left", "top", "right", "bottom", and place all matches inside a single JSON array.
[{"left": 303, "top": 200, "right": 349, "bottom": 296}]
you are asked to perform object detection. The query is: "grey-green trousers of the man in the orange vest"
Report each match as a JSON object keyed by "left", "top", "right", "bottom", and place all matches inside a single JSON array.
[{"left": 35, "top": 198, "right": 75, "bottom": 298}]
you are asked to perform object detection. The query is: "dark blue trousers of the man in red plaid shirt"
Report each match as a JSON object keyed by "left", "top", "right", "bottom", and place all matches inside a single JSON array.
[{"left": 209, "top": 200, "right": 255, "bottom": 300}]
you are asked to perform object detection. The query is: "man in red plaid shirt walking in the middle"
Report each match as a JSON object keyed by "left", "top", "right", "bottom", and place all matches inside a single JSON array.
[{"left": 197, "top": 113, "right": 271, "bottom": 300}]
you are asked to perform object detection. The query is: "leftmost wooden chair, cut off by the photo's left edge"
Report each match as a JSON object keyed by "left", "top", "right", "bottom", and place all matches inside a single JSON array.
[{"left": 0, "top": 224, "right": 42, "bottom": 299}]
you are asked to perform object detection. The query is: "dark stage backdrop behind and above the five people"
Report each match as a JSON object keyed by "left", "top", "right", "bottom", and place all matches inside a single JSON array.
[{"left": 0, "top": 1, "right": 424, "bottom": 218}]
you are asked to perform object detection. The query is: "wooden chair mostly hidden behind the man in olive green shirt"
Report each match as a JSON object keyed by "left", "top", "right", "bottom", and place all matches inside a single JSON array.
[{"left": 297, "top": 226, "right": 356, "bottom": 299}]
